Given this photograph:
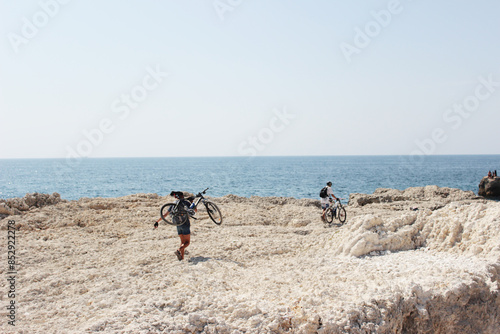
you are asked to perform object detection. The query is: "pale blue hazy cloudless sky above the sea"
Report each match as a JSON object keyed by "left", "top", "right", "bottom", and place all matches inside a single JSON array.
[{"left": 0, "top": 0, "right": 500, "bottom": 159}]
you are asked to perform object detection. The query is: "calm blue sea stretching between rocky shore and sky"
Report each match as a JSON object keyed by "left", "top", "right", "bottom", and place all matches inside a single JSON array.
[{"left": 0, "top": 155, "right": 500, "bottom": 200}]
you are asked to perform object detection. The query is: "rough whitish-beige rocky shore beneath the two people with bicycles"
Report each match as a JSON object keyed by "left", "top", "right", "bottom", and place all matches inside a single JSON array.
[{"left": 0, "top": 186, "right": 500, "bottom": 334}]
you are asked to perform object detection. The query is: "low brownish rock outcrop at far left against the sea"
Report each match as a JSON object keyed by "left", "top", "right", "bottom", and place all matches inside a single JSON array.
[{"left": 0, "top": 193, "right": 65, "bottom": 215}]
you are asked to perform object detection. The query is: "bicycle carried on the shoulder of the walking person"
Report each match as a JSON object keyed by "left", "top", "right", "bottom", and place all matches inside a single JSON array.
[{"left": 160, "top": 188, "right": 222, "bottom": 226}]
